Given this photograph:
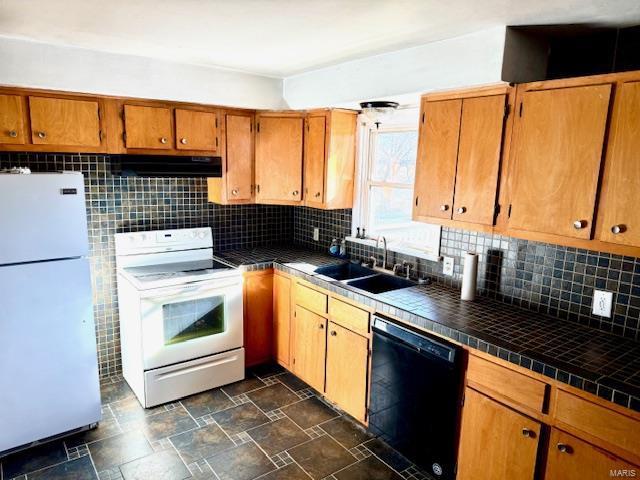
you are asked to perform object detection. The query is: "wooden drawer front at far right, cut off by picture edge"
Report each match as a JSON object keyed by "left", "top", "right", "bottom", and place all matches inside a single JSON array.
[{"left": 555, "top": 390, "right": 640, "bottom": 456}]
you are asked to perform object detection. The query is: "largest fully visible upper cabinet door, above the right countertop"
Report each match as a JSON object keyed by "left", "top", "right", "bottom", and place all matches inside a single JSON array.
[{"left": 509, "top": 85, "right": 611, "bottom": 239}]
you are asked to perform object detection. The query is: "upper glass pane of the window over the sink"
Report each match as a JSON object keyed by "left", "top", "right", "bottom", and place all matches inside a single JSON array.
[{"left": 371, "top": 130, "right": 418, "bottom": 186}]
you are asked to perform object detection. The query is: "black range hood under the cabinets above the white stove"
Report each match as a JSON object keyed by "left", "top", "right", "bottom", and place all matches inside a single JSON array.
[{"left": 111, "top": 155, "right": 222, "bottom": 177}]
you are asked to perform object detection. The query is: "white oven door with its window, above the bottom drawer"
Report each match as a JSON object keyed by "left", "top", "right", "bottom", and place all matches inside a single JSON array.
[{"left": 140, "top": 277, "right": 243, "bottom": 370}]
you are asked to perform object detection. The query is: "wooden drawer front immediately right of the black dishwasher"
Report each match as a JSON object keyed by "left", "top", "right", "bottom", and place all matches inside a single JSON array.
[{"left": 467, "top": 355, "right": 547, "bottom": 412}]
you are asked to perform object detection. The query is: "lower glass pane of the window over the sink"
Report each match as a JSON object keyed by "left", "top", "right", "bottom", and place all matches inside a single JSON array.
[{"left": 369, "top": 186, "right": 413, "bottom": 235}]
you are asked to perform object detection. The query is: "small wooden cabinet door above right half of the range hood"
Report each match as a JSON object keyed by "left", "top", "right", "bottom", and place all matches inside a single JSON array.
[{"left": 176, "top": 108, "right": 218, "bottom": 152}]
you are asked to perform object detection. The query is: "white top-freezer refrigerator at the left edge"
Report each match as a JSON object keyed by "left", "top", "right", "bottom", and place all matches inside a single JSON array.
[{"left": 0, "top": 172, "right": 101, "bottom": 456}]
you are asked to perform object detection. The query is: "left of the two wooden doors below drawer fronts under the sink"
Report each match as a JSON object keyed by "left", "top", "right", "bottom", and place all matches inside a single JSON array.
[{"left": 292, "top": 305, "right": 327, "bottom": 392}]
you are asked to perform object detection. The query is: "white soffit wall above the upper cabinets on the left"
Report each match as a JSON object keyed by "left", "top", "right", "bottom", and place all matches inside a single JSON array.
[{"left": 0, "top": 36, "right": 284, "bottom": 109}]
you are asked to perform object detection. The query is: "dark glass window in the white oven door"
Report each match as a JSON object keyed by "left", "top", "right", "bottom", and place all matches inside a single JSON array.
[{"left": 162, "top": 295, "right": 227, "bottom": 346}]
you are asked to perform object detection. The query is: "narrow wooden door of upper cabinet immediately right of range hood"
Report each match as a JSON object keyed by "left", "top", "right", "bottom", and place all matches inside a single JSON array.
[{"left": 225, "top": 115, "right": 253, "bottom": 200}]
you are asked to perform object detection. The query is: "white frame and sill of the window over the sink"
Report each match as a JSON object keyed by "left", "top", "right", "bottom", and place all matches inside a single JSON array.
[{"left": 347, "top": 108, "right": 441, "bottom": 261}]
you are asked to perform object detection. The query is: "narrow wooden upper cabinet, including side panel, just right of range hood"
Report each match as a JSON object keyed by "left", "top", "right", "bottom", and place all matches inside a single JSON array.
[{"left": 207, "top": 111, "right": 254, "bottom": 204}]
